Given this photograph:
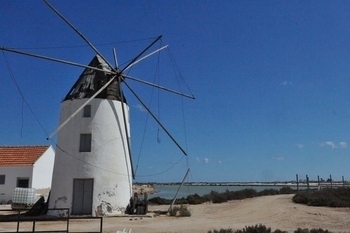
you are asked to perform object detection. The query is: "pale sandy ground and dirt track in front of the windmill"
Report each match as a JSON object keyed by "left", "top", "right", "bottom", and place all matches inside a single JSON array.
[{"left": 0, "top": 195, "right": 350, "bottom": 233}]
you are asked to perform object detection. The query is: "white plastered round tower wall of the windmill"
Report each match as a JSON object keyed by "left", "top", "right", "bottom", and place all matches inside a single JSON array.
[{"left": 49, "top": 99, "right": 132, "bottom": 216}]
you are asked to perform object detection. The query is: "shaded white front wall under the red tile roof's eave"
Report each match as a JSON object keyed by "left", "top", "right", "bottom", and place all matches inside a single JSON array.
[{"left": 0, "top": 166, "right": 33, "bottom": 203}]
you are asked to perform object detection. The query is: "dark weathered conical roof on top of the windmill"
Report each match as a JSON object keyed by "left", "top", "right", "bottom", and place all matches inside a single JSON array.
[{"left": 63, "top": 55, "right": 125, "bottom": 102}]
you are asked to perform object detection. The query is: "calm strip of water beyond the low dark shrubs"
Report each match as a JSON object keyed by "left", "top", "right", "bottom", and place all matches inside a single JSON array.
[{"left": 149, "top": 185, "right": 304, "bottom": 199}]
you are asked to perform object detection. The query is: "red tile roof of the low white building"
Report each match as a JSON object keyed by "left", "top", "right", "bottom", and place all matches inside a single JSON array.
[{"left": 0, "top": 146, "right": 49, "bottom": 167}]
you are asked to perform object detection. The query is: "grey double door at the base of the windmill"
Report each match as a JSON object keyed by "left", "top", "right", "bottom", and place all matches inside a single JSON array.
[{"left": 72, "top": 179, "right": 94, "bottom": 215}]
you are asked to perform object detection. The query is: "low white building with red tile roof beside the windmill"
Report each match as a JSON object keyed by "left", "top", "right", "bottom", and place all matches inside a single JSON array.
[{"left": 0, "top": 146, "right": 55, "bottom": 204}]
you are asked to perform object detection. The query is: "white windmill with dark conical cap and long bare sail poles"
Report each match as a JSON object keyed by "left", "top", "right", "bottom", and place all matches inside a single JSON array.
[{"left": 0, "top": 1, "right": 194, "bottom": 216}]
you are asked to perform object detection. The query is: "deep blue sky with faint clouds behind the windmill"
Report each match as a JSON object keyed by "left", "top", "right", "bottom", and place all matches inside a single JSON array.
[{"left": 0, "top": 0, "right": 350, "bottom": 182}]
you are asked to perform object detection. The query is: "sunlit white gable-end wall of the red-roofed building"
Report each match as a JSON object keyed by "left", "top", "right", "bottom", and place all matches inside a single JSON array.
[{"left": 32, "top": 146, "right": 55, "bottom": 189}]
